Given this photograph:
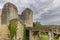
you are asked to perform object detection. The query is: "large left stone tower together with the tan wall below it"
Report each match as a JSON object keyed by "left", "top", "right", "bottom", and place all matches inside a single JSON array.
[{"left": 0, "top": 3, "right": 18, "bottom": 40}]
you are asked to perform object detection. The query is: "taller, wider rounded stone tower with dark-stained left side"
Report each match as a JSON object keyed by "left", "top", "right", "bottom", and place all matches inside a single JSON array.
[{"left": 1, "top": 3, "right": 18, "bottom": 24}]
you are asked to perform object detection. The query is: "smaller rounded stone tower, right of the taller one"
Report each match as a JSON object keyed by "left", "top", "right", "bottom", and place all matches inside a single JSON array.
[{"left": 21, "top": 8, "right": 33, "bottom": 27}]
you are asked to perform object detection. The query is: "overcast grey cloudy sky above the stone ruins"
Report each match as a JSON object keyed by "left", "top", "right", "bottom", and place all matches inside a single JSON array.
[{"left": 0, "top": 0, "right": 60, "bottom": 25}]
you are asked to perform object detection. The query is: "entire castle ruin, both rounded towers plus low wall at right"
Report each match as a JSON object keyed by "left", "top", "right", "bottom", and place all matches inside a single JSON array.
[{"left": 0, "top": 2, "right": 60, "bottom": 40}]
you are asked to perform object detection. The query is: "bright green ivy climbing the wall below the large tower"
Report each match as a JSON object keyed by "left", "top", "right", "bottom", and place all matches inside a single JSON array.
[{"left": 9, "top": 20, "right": 18, "bottom": 40}]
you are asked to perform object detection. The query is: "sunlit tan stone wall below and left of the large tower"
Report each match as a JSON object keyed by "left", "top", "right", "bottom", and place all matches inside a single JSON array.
[{"left": 0, "top": 9, "right": 9, "bottom": 40}]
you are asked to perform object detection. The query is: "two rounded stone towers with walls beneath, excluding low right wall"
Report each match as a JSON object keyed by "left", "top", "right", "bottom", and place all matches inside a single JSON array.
[{"left": 0, "top": 3, "right": 33, "bottom": 40}]
